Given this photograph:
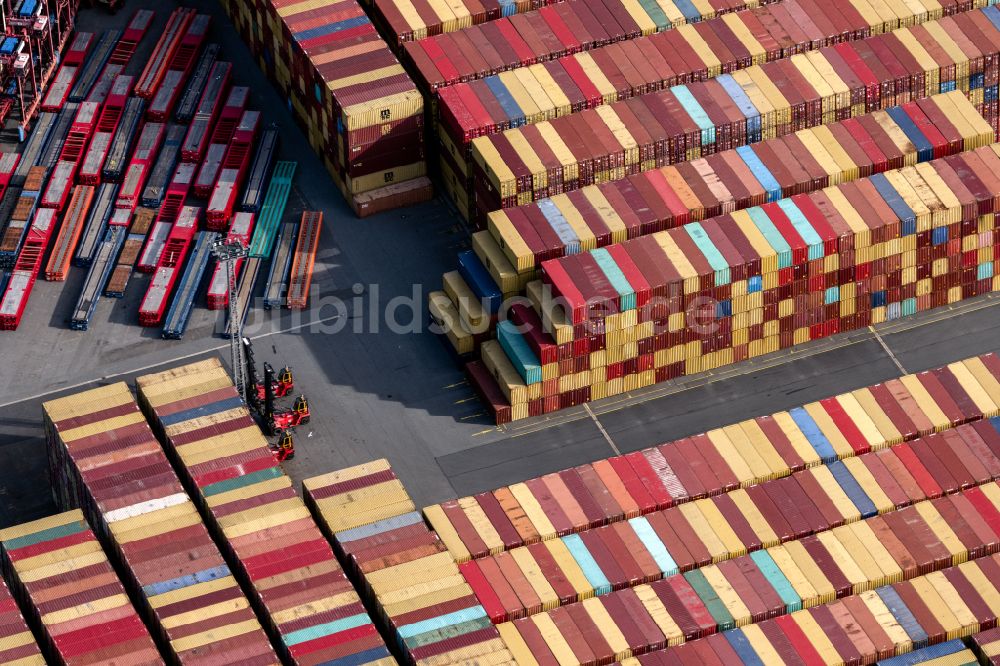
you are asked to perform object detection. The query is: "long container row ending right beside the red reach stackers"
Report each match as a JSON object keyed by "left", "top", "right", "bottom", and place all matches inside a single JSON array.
[{"left": 136, "top": 358, "right": 392, "bottom": 665}]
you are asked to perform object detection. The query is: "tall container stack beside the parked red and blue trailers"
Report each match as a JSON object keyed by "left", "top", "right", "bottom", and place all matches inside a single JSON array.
[{"left": 223, "top": 0, "right": 431, "bottom": 217}]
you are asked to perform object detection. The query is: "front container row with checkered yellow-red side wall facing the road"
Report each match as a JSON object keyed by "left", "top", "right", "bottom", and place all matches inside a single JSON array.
[{"left": 470, "top": 144, "right": 1000, "bottom": 421}]
